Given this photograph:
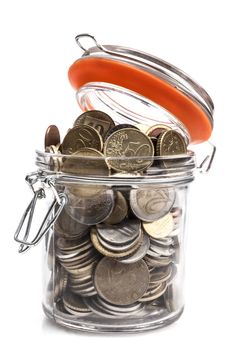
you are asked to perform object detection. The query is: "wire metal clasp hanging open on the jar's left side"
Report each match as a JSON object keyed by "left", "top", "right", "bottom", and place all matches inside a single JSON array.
[{"left": 14, "top": 172, "right": 67, "bottom": 253}]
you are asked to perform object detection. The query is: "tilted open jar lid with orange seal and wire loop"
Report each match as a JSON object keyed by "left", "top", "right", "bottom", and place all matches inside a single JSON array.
[{"left": 68, "top": 34, "right": 214, "bottom": 143}]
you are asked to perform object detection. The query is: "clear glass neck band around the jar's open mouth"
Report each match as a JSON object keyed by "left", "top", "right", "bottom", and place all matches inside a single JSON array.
[{"left": 36, "top": 151, "right": 197, "bottom": 186}]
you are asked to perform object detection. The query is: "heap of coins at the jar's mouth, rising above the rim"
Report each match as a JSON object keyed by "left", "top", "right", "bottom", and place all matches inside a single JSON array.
[{"left": 45, "top": 110, "right": 187, "bottom": 176}]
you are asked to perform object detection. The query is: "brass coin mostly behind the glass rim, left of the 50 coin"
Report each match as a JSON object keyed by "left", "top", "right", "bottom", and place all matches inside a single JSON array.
[{"left": 62, "top": 147, "right": 109, "bottom": 176}]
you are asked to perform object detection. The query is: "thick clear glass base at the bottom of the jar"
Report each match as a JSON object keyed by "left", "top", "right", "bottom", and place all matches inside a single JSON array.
[{"left": 43, "top": 304, "right": 184, "bottom": 333}]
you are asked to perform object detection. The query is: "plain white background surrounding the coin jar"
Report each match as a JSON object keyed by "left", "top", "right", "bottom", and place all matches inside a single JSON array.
[{"left": 0, "top": 0, "right": 233, "bottom": 350}]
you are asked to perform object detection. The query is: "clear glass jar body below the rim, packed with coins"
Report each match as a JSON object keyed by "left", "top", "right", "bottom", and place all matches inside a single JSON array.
[{"left": 43, "top": 180, "right": 189, "bottom": 332}]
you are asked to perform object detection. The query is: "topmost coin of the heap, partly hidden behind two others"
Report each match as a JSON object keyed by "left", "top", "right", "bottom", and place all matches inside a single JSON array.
[{"left": 74, "top": 110, "right": 115, "bottom": 139}]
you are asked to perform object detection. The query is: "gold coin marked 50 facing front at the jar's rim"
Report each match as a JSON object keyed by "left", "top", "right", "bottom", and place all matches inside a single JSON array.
[{"left": 104, "top": 128, "right": 154, "bottom": 172}]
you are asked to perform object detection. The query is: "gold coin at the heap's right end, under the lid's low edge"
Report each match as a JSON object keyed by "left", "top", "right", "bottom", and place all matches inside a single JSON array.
[{"left": 156, "top": 130, "right": 187, "bottom": 156}]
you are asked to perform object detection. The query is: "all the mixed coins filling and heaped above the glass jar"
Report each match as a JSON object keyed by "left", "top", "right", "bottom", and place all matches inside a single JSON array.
[{"left": 45, "top": 111, "right": 187, "bottom": 318}]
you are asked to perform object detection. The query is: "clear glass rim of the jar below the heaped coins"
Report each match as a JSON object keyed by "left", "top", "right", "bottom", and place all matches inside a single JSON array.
[{"left": 36, "top": 150, "right": 197, "bottom": 185}]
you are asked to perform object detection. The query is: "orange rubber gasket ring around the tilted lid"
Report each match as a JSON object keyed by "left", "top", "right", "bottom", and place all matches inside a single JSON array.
[{"left": 68, "top": 57, "right": 212, "bottom": 143}]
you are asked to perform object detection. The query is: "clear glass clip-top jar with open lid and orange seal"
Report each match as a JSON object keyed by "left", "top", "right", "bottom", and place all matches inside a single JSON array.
[{"left": 15, "top": 34, "right": 215, "bottom": 332}]
